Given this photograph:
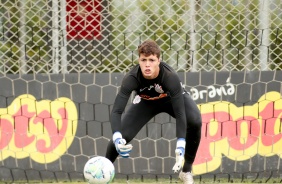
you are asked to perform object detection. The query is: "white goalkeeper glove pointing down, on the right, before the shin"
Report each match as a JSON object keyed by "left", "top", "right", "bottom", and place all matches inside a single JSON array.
[{"left": 172, "top": 138, "right": 186, "bottom": 173}]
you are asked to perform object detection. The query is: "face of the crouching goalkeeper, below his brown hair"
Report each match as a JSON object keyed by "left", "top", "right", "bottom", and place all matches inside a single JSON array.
[{"left": 139, "top": 54, "right": 160, "bottom": 79}]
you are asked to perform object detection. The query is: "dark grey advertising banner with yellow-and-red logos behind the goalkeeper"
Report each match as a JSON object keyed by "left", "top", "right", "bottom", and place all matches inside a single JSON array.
[{"left": 0, "top": 71, "right": 282, "bottom": 181}]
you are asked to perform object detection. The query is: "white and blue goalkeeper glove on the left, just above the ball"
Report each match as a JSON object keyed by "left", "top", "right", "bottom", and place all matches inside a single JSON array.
[{"left": 113, "top": 132, "right": 132, "bottom": 158}]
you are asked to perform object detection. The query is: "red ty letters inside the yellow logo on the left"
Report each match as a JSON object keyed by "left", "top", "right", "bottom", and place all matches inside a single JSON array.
[{"left": 0, "top": 105, "right": 68, "bottom": 153}]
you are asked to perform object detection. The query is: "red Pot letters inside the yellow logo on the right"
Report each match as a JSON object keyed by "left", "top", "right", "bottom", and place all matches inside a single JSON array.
[{"left": 194, "top": 102, "right": 282, "bottom": 165}]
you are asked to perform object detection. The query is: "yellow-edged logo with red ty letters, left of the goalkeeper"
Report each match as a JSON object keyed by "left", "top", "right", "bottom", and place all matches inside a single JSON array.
[{"left": 0, "top": 94, "right": 77, "bottom": 163}]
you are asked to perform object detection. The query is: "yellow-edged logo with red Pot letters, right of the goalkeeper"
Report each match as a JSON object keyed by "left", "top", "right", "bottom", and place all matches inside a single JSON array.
[{"left": 194, "top": 92, "right": 282, "bottom": 174}]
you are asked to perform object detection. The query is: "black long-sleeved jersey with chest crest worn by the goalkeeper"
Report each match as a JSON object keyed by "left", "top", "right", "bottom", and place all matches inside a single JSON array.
[{"left": 110, "top": 62, "right": 186, "bottom": 137}]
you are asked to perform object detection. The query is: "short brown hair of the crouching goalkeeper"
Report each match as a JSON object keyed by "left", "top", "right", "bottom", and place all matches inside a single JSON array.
[{"left": 138, "top": 40, "right": 161, "bottom": 58}]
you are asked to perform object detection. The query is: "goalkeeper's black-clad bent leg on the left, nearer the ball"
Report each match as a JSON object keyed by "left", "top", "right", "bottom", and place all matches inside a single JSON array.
[{"left": 106, "top": 100, "right": 156, "bottom": 162}]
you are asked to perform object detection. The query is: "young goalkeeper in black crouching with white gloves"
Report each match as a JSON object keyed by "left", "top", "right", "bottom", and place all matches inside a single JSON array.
[{"left": 106, "top": 40, "right": 202, "bottom": 184}]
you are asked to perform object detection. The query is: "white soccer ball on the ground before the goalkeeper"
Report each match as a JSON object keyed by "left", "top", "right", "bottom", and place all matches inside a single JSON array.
[{"left": 83, "top": 156, "right": 115, "bottom": 184}]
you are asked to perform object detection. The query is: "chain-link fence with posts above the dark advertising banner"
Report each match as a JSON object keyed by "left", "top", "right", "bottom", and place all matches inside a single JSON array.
[{"left": 0, "top": 0, "right": 282, "bottom": 74}]
